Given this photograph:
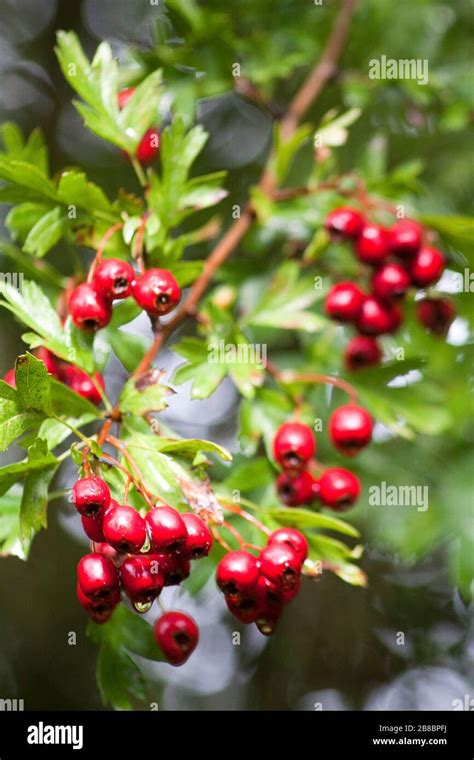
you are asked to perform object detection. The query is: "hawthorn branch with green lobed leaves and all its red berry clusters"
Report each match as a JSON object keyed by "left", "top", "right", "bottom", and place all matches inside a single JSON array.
[{"left": 0, "top": 0, "right": 472, "bottom": 709}]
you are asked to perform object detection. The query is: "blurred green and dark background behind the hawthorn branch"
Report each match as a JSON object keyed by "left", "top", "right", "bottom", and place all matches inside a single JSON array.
[{"left": 0, "top": 0, "right": 474, "bottom": 710}]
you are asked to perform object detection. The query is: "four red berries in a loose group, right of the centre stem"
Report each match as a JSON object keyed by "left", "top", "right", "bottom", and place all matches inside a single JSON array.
[{"left": 273, "top": 410, "right": 373, "bottom": 511}]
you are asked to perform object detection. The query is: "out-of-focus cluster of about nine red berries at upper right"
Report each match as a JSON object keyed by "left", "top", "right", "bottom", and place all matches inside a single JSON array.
[{"left": 325, "top": 207, "right": 455, "bottom": 370}]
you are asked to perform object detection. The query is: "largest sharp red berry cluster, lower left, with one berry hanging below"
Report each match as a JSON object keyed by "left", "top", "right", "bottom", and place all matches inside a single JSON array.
[{"left": 72, "top": 476, "right": 212, "bottom": 665}]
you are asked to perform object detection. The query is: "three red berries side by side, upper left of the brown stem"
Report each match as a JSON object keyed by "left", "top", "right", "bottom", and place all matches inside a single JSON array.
[{"left": 69, "top": 259, "right": 181, "bottom": 331}]
